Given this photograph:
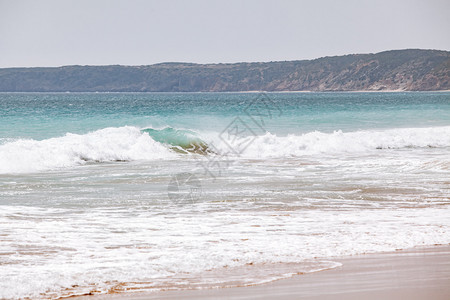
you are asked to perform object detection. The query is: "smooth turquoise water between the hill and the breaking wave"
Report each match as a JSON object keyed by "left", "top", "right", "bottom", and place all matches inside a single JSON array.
[{"left": 0, "top": 92, "right": 450, "bottom": 139}]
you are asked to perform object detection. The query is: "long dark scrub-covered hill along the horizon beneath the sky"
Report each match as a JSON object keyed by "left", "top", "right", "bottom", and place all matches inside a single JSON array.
[{"left": 0, "top": 50, "right": 450, "bottom": 92}]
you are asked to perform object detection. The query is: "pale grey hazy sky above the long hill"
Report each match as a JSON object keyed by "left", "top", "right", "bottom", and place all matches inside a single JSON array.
[{"left": 0, "top": 0, "right": 450, "bottom": 68}]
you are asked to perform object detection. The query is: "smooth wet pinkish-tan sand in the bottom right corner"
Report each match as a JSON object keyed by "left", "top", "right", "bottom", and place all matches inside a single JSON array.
[{"left": 76, "top": 245, "right": 450, "bottom": 300}]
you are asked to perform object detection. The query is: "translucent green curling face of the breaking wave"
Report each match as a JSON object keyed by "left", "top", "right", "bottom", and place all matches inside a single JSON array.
[{"left": 142, "top": 127, "right": 211, "bottom": 154}]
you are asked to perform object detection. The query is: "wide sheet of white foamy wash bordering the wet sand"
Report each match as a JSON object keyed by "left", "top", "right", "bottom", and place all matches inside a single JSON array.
[{"left": 0, "top": 203, "right": 450, "bottom": 299}]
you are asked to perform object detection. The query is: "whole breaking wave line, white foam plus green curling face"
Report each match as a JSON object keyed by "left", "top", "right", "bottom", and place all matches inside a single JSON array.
[{"left": 0, "top": 126, "right": 450, "bottom": 174}]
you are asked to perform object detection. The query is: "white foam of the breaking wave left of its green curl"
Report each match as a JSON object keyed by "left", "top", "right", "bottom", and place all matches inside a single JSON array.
[{"left": 0, "top": 126, "right": 175, "bottom": 174}]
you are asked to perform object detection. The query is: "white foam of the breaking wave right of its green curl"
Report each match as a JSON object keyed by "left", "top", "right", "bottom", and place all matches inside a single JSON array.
[{"left": 215, "top": 126, "right": 450, "bottom": 158}]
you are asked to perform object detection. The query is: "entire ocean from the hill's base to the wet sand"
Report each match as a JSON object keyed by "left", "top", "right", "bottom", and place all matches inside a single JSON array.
[{"left": 0, "top": 92, "right": 450, "bottom": 299}]
